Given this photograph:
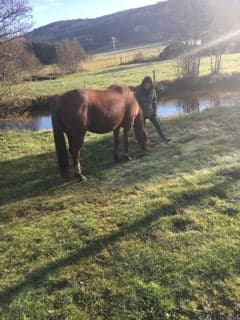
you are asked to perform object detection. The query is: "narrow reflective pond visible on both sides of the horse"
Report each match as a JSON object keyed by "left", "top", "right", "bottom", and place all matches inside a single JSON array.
[{"left": 0, "top": 92, "right": 240, "bottom": 131}]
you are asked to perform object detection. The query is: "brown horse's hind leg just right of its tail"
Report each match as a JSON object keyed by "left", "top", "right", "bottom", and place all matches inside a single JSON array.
[{"left": 69, "top": 132, "right": 87, "bottom": 181}]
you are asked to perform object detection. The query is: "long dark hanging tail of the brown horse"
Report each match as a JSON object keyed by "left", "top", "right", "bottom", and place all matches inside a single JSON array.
[{"left": 51, "top": 97, "right": 69, "bottom": 177}]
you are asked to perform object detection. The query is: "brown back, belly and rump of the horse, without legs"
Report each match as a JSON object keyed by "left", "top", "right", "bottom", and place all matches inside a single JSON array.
[{"left": 54, "top": 85, "right": 139, "bottom": 133}]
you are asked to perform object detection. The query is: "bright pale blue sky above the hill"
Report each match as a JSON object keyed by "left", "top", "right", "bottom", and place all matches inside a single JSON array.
[{"left": 29, "top": 0, "right": 159, "bottom": 28}]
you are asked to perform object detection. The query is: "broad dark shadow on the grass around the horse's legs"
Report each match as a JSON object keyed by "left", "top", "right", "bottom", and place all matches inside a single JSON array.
[{"left": 0, "top": 119, "right": 238, "bottom": 206}]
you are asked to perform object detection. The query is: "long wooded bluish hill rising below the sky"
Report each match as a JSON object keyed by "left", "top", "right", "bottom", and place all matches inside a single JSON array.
[{"left": 26, "top": 0, "right": 240, "bottom": 53}]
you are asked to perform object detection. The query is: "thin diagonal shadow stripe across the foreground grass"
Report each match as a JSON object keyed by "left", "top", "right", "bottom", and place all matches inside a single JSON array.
[{"left": 0, "top": 168, "right": 240, "bottom": 305}]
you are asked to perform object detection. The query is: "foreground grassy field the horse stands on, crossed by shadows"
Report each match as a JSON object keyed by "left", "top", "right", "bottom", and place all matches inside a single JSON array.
[{"left": 0, "top": 107, "right": 240, "bottom": 320}]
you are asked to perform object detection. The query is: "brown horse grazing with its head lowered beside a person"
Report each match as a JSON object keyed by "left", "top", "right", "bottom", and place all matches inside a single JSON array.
[{"left": 52, "top": 85, "right": 147, "bottom": 181}]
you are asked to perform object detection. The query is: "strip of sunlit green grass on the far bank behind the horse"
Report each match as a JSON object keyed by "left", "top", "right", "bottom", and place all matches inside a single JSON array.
[{"left": 13, "top": 63, "right": 174, "bottom": 97}]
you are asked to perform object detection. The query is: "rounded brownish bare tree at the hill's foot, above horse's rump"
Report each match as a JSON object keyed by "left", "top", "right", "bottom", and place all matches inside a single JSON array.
[{"left": 57, "top": 38, "right": 86, "bottom": 73}]
